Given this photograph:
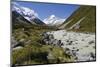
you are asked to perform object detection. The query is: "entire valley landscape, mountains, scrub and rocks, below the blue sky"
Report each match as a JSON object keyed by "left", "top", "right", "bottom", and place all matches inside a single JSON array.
[{"left": 11, "top": 1, "right": 96, "bottom": 66}]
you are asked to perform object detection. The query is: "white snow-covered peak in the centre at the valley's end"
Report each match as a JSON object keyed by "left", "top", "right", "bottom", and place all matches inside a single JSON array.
[{"left": 43, "top": 15, "right": 65, "bottom": 26}]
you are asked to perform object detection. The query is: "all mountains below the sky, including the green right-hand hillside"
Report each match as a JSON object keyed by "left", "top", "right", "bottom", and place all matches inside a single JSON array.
[{"left": 12, "top": 3, "right": 96, "bottom": 32}]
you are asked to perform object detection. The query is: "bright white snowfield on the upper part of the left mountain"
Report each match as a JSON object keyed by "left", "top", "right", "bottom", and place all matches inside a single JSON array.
[{"left": 12, "top": 2, "right": 38, "bottom": 21}]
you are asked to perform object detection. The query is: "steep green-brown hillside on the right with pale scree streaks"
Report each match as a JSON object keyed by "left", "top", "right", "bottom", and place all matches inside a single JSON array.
[{"left": 59, "top": 6, "right": 96, "bottom": 32}]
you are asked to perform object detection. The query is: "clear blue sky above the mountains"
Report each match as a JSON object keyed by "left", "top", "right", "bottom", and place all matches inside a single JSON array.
[{"left": 14, "top": 1, "right": 79, "bottom": 20}]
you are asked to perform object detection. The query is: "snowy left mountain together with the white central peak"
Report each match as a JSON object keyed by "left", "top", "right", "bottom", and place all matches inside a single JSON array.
[{"left": 12, "top": 3, "right": 65, "bottom": 26}]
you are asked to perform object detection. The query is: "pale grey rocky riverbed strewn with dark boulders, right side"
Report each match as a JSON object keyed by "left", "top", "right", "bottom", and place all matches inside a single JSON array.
[{"left": 42, "top": 30, "right": 96, "bottom": 62}]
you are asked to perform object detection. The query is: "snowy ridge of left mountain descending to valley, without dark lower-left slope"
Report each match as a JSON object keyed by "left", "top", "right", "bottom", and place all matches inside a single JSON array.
[{"left": 12, "top": 2, "right": 45, "bottom": 24}]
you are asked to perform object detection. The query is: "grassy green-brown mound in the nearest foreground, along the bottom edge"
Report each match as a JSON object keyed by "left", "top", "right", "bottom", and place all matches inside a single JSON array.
[{"left": 12, "top": 45, "right": 72, "bottom": 65}]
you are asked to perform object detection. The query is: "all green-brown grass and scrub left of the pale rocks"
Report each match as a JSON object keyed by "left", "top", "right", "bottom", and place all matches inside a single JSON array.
[{"left": 12, "top": 26, "right": 73, "bottom": 65}]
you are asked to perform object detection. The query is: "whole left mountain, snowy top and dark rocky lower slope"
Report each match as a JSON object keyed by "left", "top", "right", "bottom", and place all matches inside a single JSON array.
[{"left": 11, "top": 3, "right": 45, "bottom": 25}]
